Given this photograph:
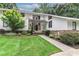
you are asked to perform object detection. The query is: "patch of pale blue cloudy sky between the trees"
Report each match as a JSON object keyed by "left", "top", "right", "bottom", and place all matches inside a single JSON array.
[{"left": 16, "top": 3, "right": 39, "bottom": 12}]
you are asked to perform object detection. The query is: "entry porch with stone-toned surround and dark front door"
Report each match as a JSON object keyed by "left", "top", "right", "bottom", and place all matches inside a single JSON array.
[{"left": 29, "top": 19, "right": 47, "bottom": 33}]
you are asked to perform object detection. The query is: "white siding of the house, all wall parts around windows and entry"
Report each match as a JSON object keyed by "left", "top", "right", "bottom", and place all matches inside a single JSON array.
[{"left": 0, "top": 11, "right": 79, "bottom": 31}]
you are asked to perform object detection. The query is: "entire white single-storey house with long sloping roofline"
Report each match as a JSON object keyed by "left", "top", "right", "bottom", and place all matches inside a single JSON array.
[{"left": 0, "top": 9, "right": 79, "bottom": 31}]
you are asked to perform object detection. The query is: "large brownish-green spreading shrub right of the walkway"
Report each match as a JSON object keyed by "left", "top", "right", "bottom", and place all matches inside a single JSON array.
[{"left": 59, "top": 33, "right": 79, "bottom": 46}]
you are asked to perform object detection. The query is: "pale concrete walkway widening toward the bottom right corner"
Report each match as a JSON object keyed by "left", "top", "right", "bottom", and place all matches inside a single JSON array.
[{"left": 39, "top": 35, "right": 79, "bottom": 56}]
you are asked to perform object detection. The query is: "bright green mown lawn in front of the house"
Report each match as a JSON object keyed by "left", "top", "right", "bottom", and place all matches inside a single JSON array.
[{"left": 0, "top": 35, "right": 61, "bottom": 56}]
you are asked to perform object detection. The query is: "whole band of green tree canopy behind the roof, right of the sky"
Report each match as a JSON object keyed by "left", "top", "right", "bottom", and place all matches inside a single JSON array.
[{"left": 34, "top": 3, "right": 79, "bottom": 18}]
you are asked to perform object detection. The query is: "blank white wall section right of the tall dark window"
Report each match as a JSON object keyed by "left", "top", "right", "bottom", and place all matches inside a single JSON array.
[{"left": 48, "top": 18, "right": 67, "bottom": 30}]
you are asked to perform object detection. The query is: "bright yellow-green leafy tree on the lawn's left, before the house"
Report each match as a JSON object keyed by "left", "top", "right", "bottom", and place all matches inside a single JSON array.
[{"left": 2, "top": 10, "right": 24, "bottom": 32}]
